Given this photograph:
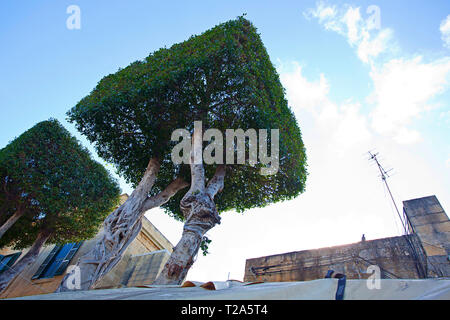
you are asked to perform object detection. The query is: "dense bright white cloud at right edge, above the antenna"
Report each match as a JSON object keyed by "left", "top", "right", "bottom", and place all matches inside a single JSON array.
[{"left": 369, "top": 56, "right": 450, "bottom": 143}]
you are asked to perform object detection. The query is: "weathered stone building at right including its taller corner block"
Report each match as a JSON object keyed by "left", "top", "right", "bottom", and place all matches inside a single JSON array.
[{"left": 244, "top": 196, "right": 450, "bottom": 282}]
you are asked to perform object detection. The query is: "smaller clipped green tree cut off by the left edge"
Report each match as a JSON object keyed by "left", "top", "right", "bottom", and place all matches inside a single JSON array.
[{"left": 0, "top": 119, "right": 120, "bottom": 291}]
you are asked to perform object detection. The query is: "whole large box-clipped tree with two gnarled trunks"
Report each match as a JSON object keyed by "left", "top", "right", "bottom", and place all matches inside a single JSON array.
[{"left": 60, "top": 17, "right": 307, "bottom": 290}]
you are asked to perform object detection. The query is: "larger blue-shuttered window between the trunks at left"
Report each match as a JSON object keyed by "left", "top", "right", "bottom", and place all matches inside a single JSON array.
[{"left": 31, "top": 242, "right": 83, "bottom": 279}]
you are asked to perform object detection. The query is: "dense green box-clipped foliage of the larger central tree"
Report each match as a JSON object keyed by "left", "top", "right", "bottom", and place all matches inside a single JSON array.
[{"left": 68, "top": 17, "right": 307, "bottom": 220}]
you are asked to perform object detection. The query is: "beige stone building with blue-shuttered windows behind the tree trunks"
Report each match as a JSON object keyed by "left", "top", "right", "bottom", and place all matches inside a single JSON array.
[{"left": 0, "top": 194, "right": 173, "bottom": 298}]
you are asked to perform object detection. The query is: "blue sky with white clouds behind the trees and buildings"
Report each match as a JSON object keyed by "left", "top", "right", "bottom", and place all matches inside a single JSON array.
[{"left": 0, "top": 0, "right": 450, "bottom": 281}]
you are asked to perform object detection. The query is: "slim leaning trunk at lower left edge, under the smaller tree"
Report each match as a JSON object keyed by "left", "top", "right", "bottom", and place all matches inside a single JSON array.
[{"left": 0, "top": 230, "right": 52, "bottom": 292}]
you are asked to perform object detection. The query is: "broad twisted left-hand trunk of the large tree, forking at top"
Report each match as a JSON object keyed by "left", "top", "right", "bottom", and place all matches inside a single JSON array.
[{"left": 56, "top": 159, "right": 187, "bottom": 292}]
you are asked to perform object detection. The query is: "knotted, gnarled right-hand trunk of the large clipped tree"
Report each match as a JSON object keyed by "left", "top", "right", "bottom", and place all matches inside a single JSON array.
[{"left": 153, "top": 125, "right": 225, "bottom": 285}]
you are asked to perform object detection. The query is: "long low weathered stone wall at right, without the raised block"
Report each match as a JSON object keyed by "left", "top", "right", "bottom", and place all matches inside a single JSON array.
[{"left": 244, "top": 236, "right": 419, "bottom": 282}]
